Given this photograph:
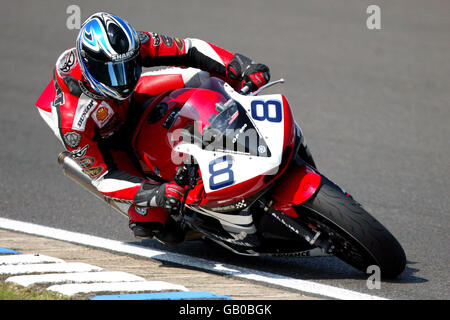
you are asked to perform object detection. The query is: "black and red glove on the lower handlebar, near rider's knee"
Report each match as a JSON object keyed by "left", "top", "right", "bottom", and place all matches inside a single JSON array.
[{"left": 134, "top": 181, "right": 184, "bottom": 213}]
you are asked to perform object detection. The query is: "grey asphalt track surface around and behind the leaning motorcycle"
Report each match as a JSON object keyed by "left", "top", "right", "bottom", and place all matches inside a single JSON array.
[{"left": 0, "top": 0, "right": 450, "bottom": 299}]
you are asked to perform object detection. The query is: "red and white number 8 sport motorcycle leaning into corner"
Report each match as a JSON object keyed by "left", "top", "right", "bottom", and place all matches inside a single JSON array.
[{"left": 54, "top": 78, "right": 406, "bottom": 278}]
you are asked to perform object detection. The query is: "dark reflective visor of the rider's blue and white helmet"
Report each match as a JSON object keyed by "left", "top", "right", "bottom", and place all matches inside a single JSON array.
[{"left": 85, "top": 54, "right": 142, "bottom": 89}]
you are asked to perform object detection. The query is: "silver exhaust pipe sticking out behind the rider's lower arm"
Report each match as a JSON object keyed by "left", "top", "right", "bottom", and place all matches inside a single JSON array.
[{"left": 58, "top": 151, "right": 130, "bottom": 217}]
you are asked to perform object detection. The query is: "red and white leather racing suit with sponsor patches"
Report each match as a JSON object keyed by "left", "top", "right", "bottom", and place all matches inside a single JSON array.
[{"left": 40, "top": 32, "right": 243, "bottom": 223}]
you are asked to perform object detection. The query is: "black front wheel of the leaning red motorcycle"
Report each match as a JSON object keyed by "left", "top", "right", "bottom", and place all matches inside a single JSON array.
[{"left": 295, "top": 175, "right": 406, "bottom": 278}]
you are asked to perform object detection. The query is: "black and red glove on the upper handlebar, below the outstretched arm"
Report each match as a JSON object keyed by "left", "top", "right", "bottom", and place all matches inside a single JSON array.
[{"left": 227, "top": 53, "right": 270, "bottom": 91}]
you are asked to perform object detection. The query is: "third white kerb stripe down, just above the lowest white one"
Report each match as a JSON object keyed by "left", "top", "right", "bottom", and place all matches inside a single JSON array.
[{"left": 6, "top": 271, "right": 145, "bottom": 287}]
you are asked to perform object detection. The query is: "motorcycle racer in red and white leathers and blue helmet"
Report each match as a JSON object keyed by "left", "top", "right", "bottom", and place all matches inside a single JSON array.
[{"left": 41, "top": 12, "right": 270, "bottom": 243}]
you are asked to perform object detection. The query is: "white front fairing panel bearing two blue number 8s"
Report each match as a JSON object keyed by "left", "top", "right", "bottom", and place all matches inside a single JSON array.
[{"left": 174, "top": 84, "right": 285, "bottom": 193}]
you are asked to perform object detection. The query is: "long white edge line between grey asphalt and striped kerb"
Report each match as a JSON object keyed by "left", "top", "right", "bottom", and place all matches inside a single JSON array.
[{"left": 0, "top": 218, "right": 384, "bottom": 300}]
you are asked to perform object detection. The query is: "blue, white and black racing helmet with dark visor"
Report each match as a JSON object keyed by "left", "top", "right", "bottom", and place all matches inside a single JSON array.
[{"left": 76, "top": 12, "right": 142, "bottom": 100}]
